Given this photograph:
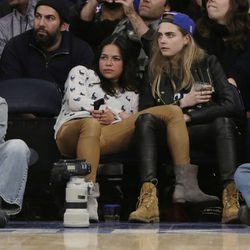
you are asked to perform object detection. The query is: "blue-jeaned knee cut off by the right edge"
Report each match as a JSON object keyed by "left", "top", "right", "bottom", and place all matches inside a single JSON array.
[{"left": 234, "top": 163, "right": 250, "bottom": 208}]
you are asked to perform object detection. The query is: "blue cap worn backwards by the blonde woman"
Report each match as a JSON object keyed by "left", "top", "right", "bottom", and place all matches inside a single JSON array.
[{"left": 161, "top": 11, "right": 195, "bottom": 35}]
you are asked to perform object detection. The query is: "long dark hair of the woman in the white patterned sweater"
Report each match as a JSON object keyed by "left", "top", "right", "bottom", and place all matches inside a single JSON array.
[{"left": 95, "top": 34, "right": 138, "bottom": 96}]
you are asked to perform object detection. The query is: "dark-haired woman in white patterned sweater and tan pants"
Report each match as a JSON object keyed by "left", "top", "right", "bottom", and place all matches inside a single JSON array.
[{"left": 55, "top": 35, "right": 216, "bottom": 221}]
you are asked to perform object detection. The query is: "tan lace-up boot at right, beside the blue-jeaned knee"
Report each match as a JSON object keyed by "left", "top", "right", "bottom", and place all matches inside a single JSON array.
[{"left": 222, "top": 182, "right": 240, "bottom": 223}]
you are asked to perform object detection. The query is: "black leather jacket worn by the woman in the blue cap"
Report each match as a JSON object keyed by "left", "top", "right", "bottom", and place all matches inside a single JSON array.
[{"left": 139, "top": 56, "right": 239, "bottom": 123}]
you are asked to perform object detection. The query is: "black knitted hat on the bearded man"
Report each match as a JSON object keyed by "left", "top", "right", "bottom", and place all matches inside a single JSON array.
[{"left": 35, "top": 0, "right": 69, "bottom": 22}]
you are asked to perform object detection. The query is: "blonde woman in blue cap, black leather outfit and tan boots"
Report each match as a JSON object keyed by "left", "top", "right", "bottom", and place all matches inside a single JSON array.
[{"left": 130, "top": 12, "right": 239, "bottom": 222}]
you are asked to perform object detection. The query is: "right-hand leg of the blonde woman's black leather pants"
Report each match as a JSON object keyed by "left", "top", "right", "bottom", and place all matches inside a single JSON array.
[{"left": 188, "top": 117, "right": 238, "bottom": 185}]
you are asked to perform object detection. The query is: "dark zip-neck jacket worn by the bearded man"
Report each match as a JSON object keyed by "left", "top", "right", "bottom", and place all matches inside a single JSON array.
[{"left": 0, "top": 30, "right": 93, "bottom": 90}]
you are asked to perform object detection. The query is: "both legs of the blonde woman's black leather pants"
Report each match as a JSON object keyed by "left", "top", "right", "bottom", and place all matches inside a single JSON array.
[{"left": 135, "top": 114, "right": 238, "bottom": 185}]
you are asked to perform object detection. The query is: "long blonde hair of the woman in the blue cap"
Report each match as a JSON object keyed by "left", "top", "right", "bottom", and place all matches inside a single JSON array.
[{"left": 149, "top": 27, "right": 205, "bottom": 98}]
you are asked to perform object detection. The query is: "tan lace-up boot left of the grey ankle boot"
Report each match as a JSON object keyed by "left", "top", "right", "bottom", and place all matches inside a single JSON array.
[{"left": 128, "top": 182, "right": 160, "bottom": 223}]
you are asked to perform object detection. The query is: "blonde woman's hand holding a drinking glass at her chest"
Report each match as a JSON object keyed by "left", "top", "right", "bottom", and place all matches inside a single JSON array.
[{"left": 180, "top": 86, "right": 213, "bottom": 108}]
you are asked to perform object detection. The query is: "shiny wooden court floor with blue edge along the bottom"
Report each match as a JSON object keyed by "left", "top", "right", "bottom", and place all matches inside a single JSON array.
[{"left": 0, "top": 221, "right": 250, "bottom": 250}]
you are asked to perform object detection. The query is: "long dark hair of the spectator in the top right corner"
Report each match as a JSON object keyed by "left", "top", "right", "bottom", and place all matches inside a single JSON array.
[{"left": 196, "top": 0, "right": 250, "bottom": 49}]
